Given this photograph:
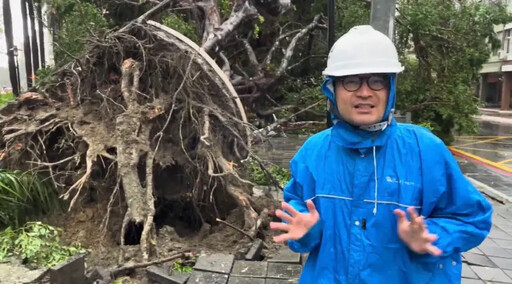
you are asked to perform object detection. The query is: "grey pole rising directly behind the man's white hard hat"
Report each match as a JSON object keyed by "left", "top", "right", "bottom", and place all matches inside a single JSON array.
[{"left": 370, "top": 0, "right": 396, "bottom": 40}]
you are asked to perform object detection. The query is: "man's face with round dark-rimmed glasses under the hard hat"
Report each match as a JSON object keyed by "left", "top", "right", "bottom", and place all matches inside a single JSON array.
[{"left": 334, "top": 74, "right": 389, "bottom": 126}]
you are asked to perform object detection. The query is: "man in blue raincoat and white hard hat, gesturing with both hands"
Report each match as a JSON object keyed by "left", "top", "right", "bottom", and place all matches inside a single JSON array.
[{"left": 271, "top": 26, "right": 492, "bottom": 284}]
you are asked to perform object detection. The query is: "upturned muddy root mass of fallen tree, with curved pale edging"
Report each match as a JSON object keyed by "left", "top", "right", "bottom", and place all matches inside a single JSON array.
[{"left": 0, "top": 18, "right": 274, "bottom": 259}]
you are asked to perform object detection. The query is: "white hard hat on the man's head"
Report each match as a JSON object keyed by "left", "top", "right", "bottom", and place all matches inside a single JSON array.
[{"left": 323, "top": 25, "right": 404, "bottom": 77}]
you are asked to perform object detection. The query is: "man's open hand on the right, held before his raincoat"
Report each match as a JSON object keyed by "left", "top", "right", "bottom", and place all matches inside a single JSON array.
[{"left": 393, "top": 207, "right": 443, "bottom": 256}]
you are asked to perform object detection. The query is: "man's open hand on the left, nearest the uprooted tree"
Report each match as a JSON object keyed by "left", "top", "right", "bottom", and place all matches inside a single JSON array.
[{"left": 270, "top": 200, "right": 320, "bottom": 243}]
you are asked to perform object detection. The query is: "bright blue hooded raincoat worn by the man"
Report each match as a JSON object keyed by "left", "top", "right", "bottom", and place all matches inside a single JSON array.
[{"left": 284, "top": 76, "right": 492, "bottom": 284}]
